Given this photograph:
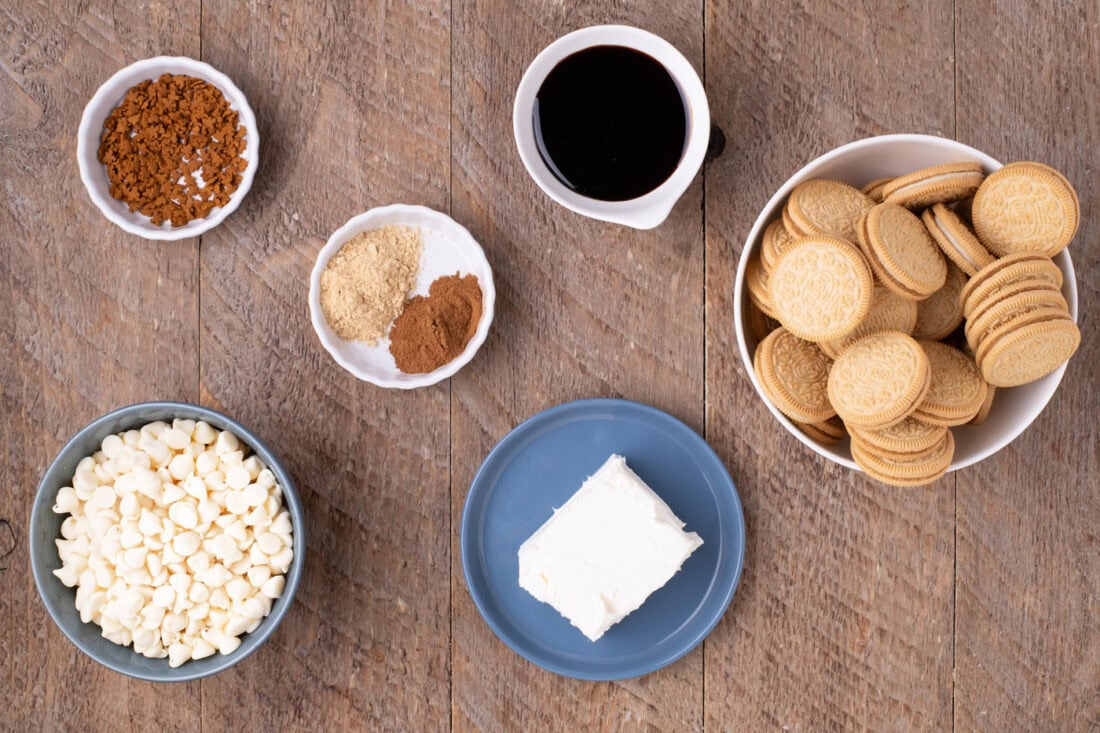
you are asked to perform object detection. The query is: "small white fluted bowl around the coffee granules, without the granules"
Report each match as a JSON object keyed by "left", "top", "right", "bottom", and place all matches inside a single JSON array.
[{"left": 76, "top": 56, "right": 260, "bottom": 240}]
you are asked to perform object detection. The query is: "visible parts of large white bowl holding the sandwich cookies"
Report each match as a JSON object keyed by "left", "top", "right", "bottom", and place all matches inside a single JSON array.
[{"left": 734, "top": 134, "right": 1077, "bottom": 471}]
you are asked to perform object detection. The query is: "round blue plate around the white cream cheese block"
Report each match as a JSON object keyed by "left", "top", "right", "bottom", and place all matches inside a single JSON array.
[{"left": 462, "top": 400, "right": 745, "bottom": 680}]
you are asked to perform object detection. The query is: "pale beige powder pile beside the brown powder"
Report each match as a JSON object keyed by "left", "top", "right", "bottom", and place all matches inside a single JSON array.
[{"left": 321, "top": 226, "right": 424, "bottom": 346}]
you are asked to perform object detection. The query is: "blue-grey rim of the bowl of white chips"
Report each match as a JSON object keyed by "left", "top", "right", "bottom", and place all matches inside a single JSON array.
[{"left": 28, "top": 401, "right": 306, "bottom": 682}]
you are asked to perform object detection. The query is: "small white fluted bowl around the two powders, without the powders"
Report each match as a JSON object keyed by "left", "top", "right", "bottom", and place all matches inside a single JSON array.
[{"left": 309, "top": 204, "right": 496, "bottom": 390}]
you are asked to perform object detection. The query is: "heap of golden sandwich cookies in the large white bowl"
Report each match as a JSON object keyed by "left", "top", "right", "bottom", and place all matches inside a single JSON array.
[{"left": 745, "top": 158, "right": 1080, "bottom": 485}]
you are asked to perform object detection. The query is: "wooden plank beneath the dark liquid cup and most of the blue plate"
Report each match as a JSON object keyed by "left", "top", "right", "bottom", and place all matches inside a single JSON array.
[{"left": 451, "top": 0, "right": 703, "bottom": 731}]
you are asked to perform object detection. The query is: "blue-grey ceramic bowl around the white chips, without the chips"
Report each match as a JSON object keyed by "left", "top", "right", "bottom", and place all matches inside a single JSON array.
[{"left": 30, "top": 402, "right": 306, "bottom": 682}]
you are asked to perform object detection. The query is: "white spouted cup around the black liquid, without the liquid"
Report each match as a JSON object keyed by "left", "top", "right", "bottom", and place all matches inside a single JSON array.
[{"left": 512, "top": 25, "right": 711, "bottom": 229}]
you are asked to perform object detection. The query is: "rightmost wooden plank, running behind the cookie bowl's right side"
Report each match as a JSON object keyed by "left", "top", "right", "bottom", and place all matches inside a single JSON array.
[{"left": 955, "top": 0, "right": 1100, "bottom": 731}]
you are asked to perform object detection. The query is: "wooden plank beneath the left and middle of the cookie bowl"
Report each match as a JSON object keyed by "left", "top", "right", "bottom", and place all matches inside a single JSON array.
[{"left": 705, "top": 1, "right": 955, "bottom": 730}]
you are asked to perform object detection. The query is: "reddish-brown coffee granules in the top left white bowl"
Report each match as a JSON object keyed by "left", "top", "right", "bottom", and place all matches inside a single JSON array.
[{"left": 98, "top": 74, "right": 248, "bottom": 227}]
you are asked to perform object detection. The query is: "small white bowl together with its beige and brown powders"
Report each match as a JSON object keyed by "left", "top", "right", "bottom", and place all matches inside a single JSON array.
[{"left": 309, "top": 204, "right": 496, "bottom": 390}]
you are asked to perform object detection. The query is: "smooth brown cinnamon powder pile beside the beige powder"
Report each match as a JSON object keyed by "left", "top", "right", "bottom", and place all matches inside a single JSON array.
[{"left": 389, "top": 273, "right": 482, "bottom": 374}]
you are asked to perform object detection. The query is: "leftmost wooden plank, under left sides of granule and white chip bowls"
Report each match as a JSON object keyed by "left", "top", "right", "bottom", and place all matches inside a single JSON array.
[{"left": 0, "top": 2, "right": 199, "bottom": 731}]
